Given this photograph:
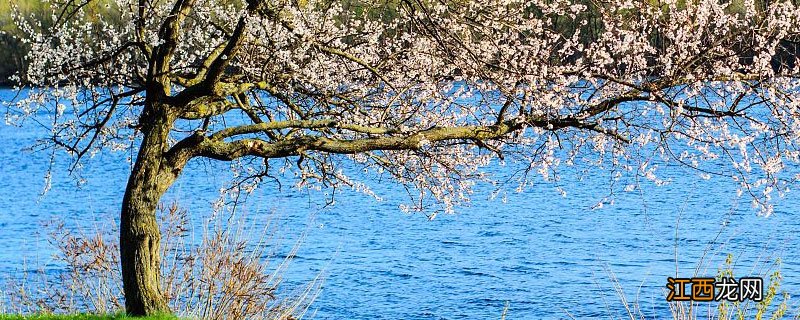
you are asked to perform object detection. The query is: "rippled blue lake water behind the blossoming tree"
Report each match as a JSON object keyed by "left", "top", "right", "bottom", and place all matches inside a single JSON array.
[{"left": 0, "top": 91, "right": 800, "bottom": 319}]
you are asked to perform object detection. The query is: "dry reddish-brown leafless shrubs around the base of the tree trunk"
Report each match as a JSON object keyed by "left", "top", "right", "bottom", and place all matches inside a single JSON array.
[{"left": 0, "top": 204, "right": 322, "bottom": 319}]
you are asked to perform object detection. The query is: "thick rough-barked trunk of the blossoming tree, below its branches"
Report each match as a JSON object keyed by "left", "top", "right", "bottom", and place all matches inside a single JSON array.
[{"left": 120, "top": 107, "right": 179, "bottom": 316}]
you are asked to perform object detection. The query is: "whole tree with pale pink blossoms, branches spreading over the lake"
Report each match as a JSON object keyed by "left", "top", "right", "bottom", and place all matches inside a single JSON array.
[{"left": 7, "top": 0, "right": 800, "bottom": 315}]
